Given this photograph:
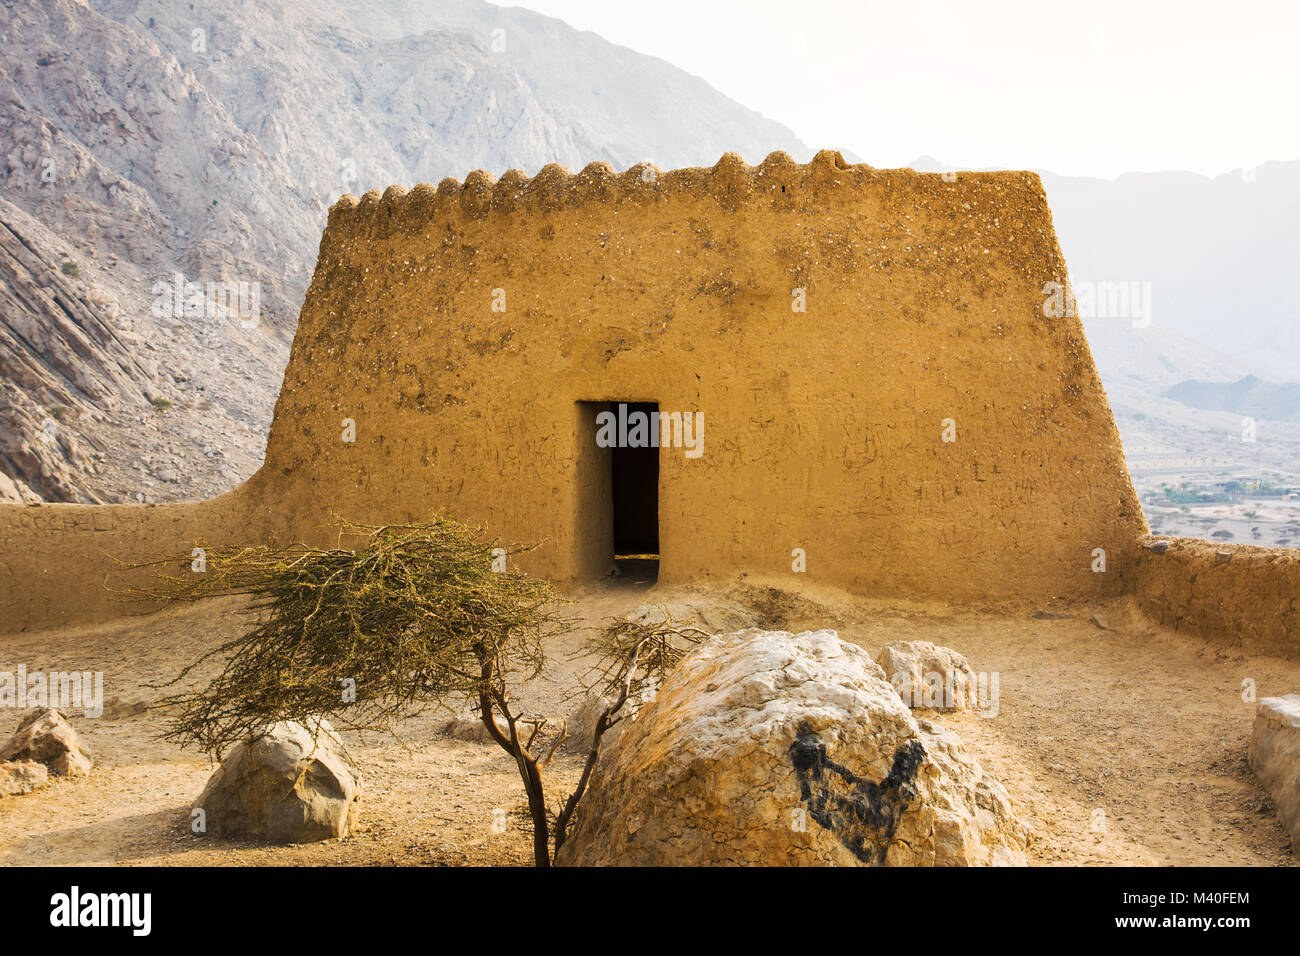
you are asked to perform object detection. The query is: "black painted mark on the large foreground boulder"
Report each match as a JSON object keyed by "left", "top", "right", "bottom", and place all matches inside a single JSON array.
[{"left": 790, "top": 727, "right": 926, "bottom": 866}]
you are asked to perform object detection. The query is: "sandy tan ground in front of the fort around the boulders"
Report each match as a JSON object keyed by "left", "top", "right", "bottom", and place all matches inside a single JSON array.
[{"left": 0, "top": 583, "right": 1300, "bottom": 866}]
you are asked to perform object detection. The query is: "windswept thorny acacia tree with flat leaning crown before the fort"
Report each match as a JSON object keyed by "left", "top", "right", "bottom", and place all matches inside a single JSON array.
[{"left": 133, "top": 518, "right": 706, "bottom": 866}]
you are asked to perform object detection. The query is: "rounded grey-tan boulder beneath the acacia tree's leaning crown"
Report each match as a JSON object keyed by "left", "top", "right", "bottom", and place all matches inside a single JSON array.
[{"left": 191, "top": 721, "right": 361, "bottom": 843}]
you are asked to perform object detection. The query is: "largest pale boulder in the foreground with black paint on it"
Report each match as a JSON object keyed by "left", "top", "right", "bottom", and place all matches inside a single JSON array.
[{"left": 556, "top": 630, "right": 1028, "bottom": 866}]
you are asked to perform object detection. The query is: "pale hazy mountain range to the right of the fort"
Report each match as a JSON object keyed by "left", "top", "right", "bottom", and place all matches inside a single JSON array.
[{"left": 1043, "top": 160, "right": 1300, "bottom": 489}]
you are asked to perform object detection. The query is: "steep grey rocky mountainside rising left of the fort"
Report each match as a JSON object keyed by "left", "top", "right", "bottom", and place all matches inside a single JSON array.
[{"left": 0, "top": 0, "right": 811, "bottom": 501}]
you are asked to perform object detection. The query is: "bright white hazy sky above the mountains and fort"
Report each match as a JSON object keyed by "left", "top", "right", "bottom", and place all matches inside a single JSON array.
[{"left": 503, "top": 0, "right": 1300, "bottom": 177}]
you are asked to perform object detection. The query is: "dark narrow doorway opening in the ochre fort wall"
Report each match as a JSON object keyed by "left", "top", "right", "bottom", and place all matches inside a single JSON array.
[{"left": 608, "top": 402, "right": 659, "bottom": 584}]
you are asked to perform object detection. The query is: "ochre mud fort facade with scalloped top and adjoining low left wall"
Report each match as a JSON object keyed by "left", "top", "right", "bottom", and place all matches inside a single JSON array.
[{"left": 0, "top": 152, "right": 1180, "bottom": 630}]
